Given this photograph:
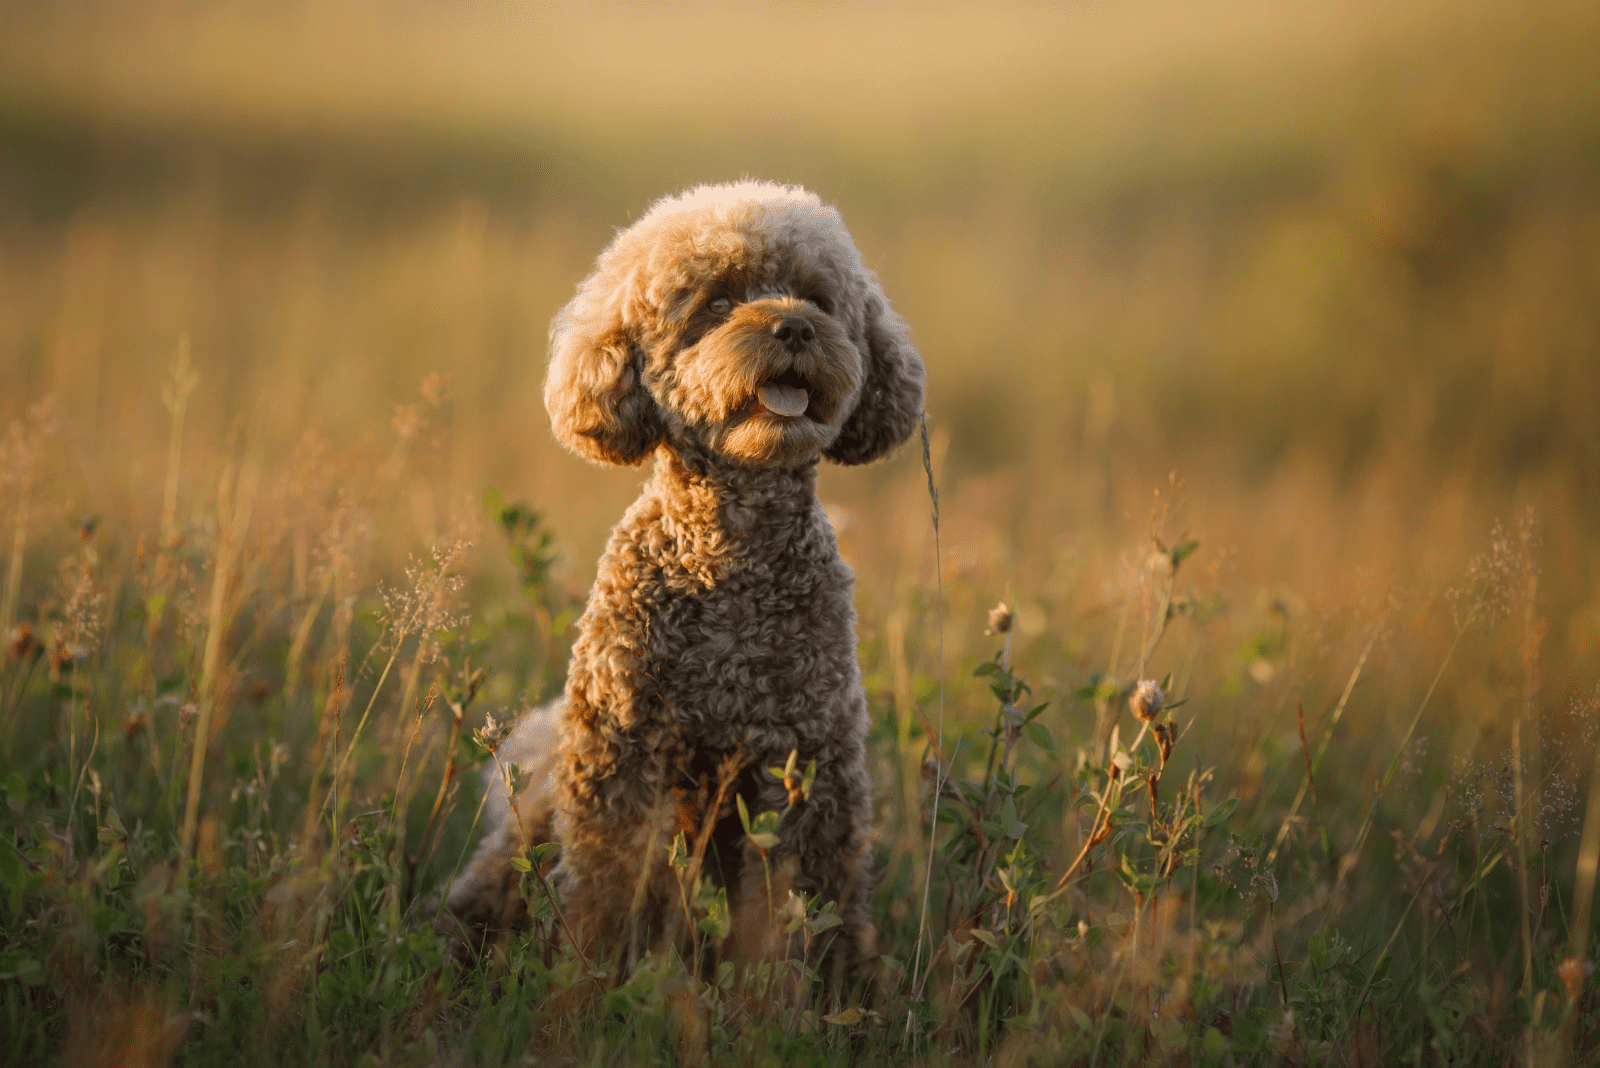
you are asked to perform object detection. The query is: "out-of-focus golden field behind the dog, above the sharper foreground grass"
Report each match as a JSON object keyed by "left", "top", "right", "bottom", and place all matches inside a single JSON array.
[{"left": 0, "top": 0, "right": 1600, "bottom": 782}]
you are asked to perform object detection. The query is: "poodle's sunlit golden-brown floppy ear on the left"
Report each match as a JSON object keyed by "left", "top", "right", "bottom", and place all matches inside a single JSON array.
[{"left": 544, "top": 294, "right": 666, "bottom": 467}]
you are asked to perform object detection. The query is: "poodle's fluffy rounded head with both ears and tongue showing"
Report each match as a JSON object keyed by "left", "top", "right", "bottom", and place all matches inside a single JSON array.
[{"left": 544, "top": 182, "right": 923, "bottom": 467}]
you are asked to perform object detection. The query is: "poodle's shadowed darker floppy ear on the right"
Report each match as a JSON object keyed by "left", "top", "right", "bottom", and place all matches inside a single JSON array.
[{"left": 824, "top": 281, "right": 925, "bottom": 464}]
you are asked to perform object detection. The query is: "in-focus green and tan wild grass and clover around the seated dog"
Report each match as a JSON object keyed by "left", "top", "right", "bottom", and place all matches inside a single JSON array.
[{"left": 0, "top": 362, "right": 1600, "bottom": 1063}]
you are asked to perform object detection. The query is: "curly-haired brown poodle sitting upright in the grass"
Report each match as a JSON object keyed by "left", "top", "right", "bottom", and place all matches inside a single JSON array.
[{"left": 448, "top": 182, "right": 923, "bottom": 959}]
